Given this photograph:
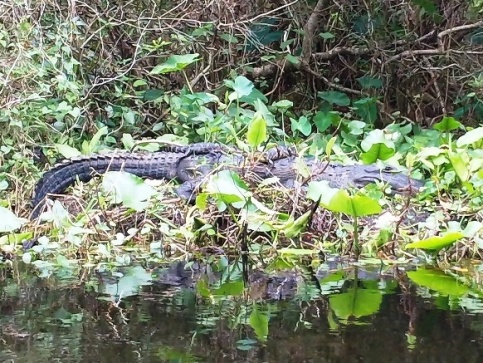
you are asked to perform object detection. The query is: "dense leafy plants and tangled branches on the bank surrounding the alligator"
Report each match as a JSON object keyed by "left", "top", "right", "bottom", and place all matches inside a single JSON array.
[{"left": 0, "top": 0, "right": 483, "bottom": 263}]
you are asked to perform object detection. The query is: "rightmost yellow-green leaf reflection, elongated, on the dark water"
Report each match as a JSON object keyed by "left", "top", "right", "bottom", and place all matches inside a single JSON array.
[{"left": 407, "top": 268, "right": 469, "bottom": 296}]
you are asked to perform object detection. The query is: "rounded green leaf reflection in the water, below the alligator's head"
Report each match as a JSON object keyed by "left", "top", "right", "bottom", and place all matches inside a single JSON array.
[{"left": 329, "top": 286, "right": 382, "bottom": 320}]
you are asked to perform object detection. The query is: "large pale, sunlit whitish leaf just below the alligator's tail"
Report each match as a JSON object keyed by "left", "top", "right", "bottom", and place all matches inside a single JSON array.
[{"left": 102, "top": 171, "right": 155, "bottom": 211}]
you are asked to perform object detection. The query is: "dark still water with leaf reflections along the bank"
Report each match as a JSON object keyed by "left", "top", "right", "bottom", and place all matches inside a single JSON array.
[{"left": 0, "top": 267, "right": 483, "bottom": 362}]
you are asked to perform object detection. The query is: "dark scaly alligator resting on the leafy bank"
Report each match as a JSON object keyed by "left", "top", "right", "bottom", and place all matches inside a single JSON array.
[{"left": 31, "top": 143, "right": 423, "bottom": 219}]
